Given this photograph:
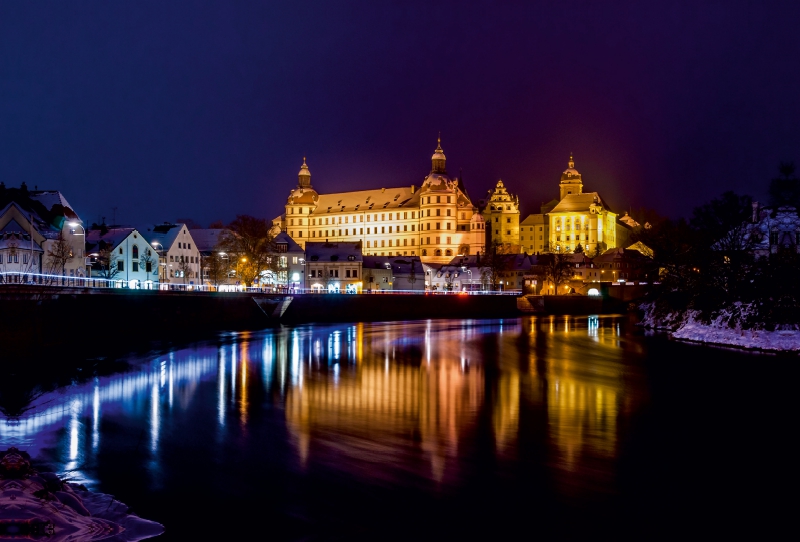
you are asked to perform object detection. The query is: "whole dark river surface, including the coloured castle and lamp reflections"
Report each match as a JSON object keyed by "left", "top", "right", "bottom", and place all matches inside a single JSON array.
[{"left": 0, "top": 317, "right": 798, "bottom": 540}]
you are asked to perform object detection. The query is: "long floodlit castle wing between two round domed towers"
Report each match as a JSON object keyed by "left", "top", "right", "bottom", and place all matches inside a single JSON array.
[{"left": 273, "top": 139, "right": 486, "bottom": 263}]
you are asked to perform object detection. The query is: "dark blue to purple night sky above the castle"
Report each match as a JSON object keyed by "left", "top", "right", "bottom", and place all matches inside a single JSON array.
[{"left": 0, "top": 0, "right": 800, "bottom": 225}]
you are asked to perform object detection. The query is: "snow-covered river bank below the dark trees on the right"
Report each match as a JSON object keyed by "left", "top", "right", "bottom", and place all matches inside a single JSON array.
[{"left": 640, "top": 302, "right": 800, "bottom": 352}]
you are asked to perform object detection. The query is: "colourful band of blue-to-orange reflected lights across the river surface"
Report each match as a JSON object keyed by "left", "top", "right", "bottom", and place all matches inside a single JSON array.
[{"left": 0, "top": 317, "right": 641, "bottom": 536}]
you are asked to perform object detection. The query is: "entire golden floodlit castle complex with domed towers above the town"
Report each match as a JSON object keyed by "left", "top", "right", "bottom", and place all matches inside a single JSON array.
[{"left": 273, "top": 142, "right": 638, "bottom": 264}]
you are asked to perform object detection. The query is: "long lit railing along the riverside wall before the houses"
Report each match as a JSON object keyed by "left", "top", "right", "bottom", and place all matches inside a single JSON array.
[{"left": 0, "top": 272, "right": 522, "bottom": 296}]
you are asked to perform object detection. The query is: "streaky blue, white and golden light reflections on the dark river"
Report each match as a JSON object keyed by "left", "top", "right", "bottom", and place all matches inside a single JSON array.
[{"left": 0, "top": 317, "right": 630, "bottom": 481}]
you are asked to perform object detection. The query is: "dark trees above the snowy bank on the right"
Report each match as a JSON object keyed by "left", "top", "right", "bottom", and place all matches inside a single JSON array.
[{"left": 635, "top": 164, "right": 800, "bottom": 327}]
